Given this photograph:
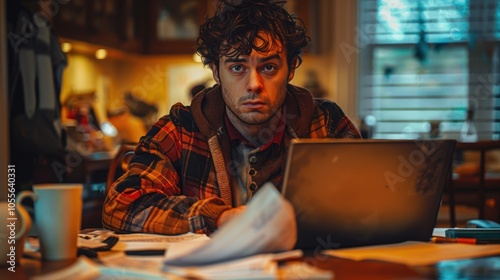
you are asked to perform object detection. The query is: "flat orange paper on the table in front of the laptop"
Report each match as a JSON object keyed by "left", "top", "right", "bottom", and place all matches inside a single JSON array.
[{"left": 322, "top": 241, "right": 500, "bottom": 266}]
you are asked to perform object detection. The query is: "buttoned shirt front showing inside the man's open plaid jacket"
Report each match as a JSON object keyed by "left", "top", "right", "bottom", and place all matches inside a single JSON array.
[{"left": 224, "top": 110, "right": 286, "bottom": 206}]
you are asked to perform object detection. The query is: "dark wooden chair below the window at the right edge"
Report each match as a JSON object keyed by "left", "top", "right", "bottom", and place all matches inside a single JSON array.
[{"left": 445, "top": 140, "right": 500, "bottom": 227}]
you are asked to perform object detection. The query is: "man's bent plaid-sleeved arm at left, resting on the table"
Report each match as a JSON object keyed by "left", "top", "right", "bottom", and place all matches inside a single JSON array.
[{"left": 103, "top": 115, "right": 231, "bottom": 234}]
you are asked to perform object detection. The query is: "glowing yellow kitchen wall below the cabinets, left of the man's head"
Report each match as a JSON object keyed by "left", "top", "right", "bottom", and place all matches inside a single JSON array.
[{"left": 61, "top": 50, "right": 208, "bottom": 119}]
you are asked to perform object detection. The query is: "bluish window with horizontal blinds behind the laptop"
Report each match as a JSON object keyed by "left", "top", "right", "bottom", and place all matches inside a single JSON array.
[{"left": 358, "top": 0, "right": 500, "bottom": 139}]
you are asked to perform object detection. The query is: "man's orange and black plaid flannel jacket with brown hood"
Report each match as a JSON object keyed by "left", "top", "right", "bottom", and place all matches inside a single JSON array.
[{"left": 103, "top": 85, "right": 361, "bottom": 234}]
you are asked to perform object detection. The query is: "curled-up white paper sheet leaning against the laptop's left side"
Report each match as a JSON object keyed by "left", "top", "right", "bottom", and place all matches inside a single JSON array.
[{"left": 165, "top": 183, "right": 297, "bottom": 266}]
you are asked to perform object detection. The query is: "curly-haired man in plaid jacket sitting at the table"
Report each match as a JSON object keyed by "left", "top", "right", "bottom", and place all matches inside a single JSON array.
[{"left": 103, "top": 0, "right": 360, "bottom": 234}]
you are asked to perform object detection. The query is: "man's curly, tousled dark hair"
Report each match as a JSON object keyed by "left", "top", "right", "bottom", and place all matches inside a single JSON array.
[{"left": 196, "top": 0, "right": 310, "bottom": 68}]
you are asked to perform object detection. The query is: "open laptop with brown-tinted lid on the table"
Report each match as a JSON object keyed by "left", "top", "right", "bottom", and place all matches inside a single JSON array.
[{"left": 282, "top": 139, "right": 456, "bottom": 249}]
